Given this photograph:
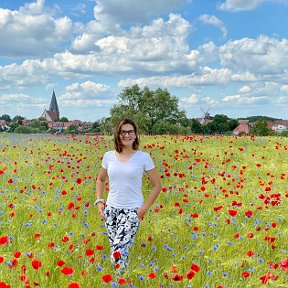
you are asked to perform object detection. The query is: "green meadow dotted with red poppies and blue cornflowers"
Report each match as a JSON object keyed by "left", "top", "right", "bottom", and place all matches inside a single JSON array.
[{"left": 0, "top": 133, "right": 288, "bottom": 288}]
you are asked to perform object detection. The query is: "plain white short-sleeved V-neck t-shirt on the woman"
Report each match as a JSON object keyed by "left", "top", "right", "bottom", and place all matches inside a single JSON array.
[{"left": 102, "top": 150, "right": 155, "bottom": 209}]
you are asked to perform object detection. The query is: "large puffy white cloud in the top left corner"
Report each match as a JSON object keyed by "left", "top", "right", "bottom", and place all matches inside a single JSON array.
[{"left": 0, "top": 0, "right": 73, "bottom": 58}]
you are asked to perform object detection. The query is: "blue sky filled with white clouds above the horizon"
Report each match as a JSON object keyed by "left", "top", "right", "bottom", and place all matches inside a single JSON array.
[{"left": 0, "top": 0, "right": 288, "bottom": 121}]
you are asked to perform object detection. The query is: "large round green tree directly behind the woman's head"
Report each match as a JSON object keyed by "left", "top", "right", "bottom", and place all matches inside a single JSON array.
[{"left": 111, "top": 85, "right": 189, "bottom": 134}]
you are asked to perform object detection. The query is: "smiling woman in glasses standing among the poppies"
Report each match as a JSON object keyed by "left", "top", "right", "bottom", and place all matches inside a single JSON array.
[{"left": 95, "top": 119, "right": 161, "bottom": 274}]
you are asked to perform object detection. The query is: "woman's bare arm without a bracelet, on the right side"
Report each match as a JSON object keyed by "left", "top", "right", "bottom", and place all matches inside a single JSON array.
[{"left": 137, "top": 168, "right": 162, "bottom": 219}]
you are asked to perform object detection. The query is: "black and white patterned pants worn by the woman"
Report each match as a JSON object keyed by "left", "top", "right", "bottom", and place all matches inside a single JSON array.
[{"left": 104, "top": 206, "right": 140, "bottom": 273}]
